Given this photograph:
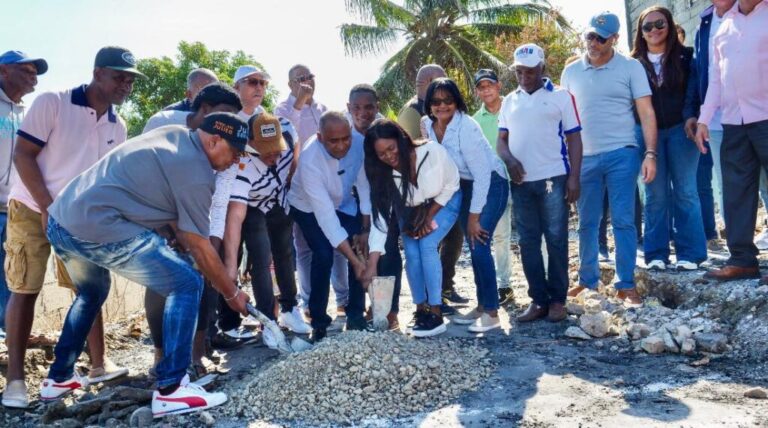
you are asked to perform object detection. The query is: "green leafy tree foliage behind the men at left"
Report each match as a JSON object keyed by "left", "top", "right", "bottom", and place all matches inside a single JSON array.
[{"left": 120, "top": 41, "right": 277, "bottom": 136}]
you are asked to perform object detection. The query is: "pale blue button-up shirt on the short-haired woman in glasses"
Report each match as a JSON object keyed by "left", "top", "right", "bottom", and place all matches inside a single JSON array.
[{"left": 424, "top": 111, "right": 507, "bottom": 214}]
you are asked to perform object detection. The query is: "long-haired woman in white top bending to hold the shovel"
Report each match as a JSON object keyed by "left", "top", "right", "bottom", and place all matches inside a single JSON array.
[{"left": 363, "top": 119, "right": 461, "bottom": 337}]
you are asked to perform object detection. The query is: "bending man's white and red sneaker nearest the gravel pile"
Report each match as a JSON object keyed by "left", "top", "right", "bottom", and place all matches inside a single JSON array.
[{"left": 152, "top": 375, "right": 227, "bottom": 418}]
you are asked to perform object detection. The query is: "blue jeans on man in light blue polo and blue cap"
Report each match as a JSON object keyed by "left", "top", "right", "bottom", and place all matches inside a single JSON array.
[{"left": 577, "top": 146, "right": 640, "bottom": 290}]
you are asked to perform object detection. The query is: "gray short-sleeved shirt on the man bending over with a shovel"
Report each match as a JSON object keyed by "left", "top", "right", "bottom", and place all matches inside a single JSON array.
[{"left": 48, "top": 125, "right": 215, "bottom": 243}]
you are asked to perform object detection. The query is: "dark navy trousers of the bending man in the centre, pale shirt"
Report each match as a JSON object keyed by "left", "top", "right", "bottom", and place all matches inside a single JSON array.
[{"left": 291, "top": 207, "right": 365, "bottom": 329}]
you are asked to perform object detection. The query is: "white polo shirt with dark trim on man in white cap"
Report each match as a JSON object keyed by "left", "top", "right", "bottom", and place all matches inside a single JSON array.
[{"left": 499, "top": 79, "right": 581, "bottom": 181}]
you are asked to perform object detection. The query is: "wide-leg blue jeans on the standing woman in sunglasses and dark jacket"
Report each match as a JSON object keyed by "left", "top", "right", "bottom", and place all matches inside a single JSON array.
[{"left": 635, "top": 124, "right": 707, "bottom": 263}]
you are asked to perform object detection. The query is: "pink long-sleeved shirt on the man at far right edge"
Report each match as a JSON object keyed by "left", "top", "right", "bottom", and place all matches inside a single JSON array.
[{"left": 699, "top": 0, "right": 768, "bottom": 125}]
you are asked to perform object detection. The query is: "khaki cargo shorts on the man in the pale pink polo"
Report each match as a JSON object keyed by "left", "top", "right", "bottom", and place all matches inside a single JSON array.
[{"left": 4, "top": 199, "right": 75, "bottom": 294}]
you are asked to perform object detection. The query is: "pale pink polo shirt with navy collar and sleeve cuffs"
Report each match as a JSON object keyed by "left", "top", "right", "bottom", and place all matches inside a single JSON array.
[{"left": 8, "top": 85, "right": 127, "bottom": 212}]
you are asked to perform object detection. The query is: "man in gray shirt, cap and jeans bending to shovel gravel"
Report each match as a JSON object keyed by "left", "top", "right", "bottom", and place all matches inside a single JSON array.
[{"left": 40, "top": 113, "right": 248, "bottom": 417}]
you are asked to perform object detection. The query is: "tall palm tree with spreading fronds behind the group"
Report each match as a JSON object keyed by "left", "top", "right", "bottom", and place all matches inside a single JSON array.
[{"left": 341, "top": 0, "right": 570, "bottom": 108}]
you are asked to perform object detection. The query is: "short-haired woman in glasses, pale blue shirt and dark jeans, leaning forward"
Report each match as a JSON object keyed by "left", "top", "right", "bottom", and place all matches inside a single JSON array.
[{"left": 424, "top": 78, "right": 509, "bottom": 333}]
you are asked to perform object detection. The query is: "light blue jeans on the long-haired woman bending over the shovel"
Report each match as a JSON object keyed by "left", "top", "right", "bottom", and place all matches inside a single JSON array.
[{"left": 401, "top": 190, "right": 461, "bottom": 306}]
